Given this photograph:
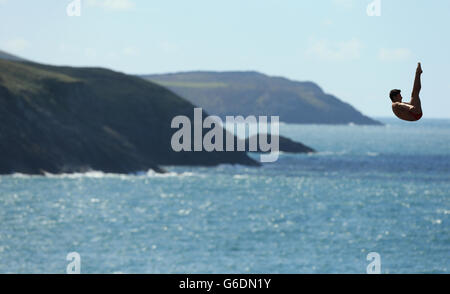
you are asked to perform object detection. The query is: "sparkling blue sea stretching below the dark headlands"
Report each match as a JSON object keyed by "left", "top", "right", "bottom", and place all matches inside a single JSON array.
[{"left": 0, "top": 118, "right": 450, "bottom": 274}]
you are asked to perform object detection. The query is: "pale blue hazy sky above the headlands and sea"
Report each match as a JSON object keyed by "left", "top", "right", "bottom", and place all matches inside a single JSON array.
[{"left": 0, "top": 0, "right": 450, "bottom": 118}]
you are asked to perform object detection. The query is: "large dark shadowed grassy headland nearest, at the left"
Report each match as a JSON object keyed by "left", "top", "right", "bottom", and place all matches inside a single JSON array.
[{"left": 0, "top": 59, "right": 255, "bottom": 173}]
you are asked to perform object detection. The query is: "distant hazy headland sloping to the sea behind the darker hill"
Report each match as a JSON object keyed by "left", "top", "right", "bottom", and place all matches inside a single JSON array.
[{"left": 143, "top": 72, "right": 380, "bottom": 124}]
